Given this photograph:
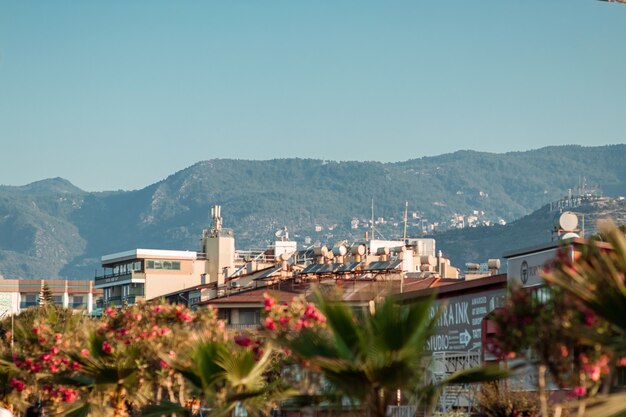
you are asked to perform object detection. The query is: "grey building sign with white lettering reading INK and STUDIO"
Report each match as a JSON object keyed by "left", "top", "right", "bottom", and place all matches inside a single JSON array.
[{"left": 426, "top": 288, "right": 506, "bottom": 352}]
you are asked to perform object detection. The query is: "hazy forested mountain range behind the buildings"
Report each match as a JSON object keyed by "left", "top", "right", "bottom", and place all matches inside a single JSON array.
[{"left": 0, "top": 145, "right": 626, "bottom": 279}]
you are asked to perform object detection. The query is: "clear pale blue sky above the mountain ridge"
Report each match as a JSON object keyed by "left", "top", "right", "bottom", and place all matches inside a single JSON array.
[{"left": 0, "top": 0, "right": 626, "bottom": 191}]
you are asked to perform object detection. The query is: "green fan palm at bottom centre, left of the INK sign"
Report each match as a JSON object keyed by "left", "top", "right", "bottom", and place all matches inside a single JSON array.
[{"left": 279, "top": 292, "right": 496, "bottom": 417}]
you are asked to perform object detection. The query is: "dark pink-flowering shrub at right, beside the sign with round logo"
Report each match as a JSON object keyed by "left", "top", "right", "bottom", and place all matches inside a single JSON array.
[{"left": 488, "top": 286, "right": 609, "bottom": 397}]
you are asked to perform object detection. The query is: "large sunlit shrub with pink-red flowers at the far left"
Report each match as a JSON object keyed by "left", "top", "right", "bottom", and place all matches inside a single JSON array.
[{"left": 0, "top": 304, "right": 227, "bottom": 414}]
